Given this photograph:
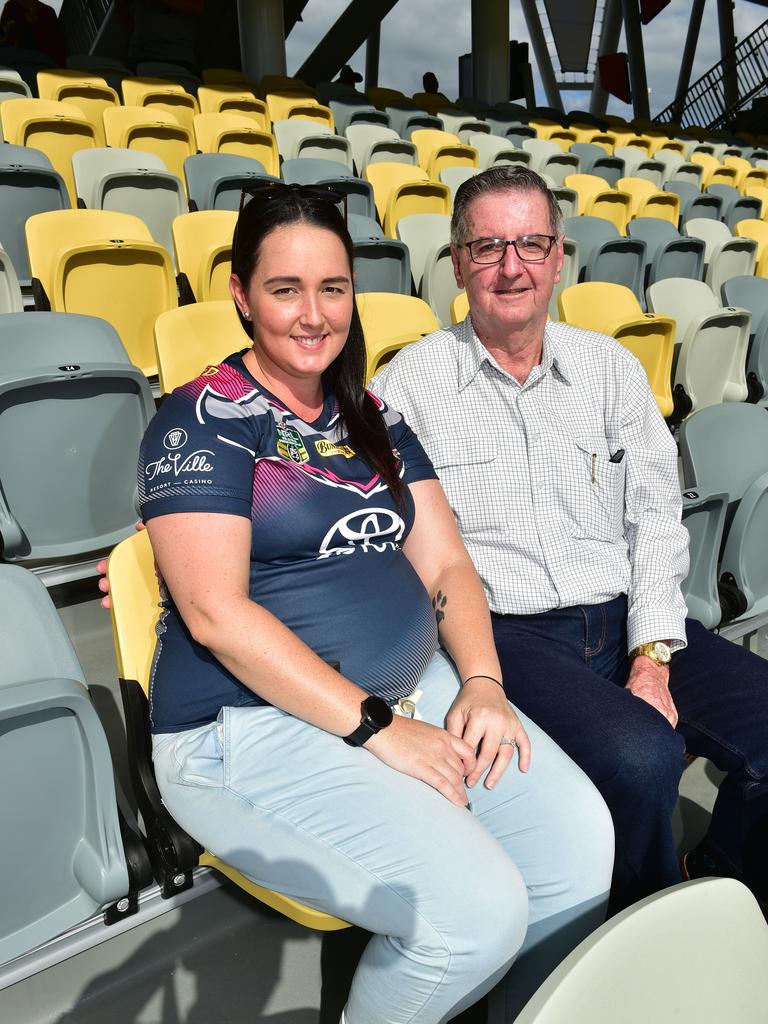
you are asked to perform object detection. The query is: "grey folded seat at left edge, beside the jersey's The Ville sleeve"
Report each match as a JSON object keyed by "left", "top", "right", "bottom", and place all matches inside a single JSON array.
[{"left": 0, "top": 309, "right": 155, "bottom": 569}]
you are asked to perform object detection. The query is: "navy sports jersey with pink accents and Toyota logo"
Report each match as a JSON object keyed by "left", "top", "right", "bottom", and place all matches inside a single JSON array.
[{"left": 138, "top": 355, "right": 437, "bottom": 732}]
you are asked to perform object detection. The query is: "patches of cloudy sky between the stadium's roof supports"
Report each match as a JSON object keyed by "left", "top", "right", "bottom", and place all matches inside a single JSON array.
[{"left": 288, "top": 0, "right": 768, "bottom": 117}]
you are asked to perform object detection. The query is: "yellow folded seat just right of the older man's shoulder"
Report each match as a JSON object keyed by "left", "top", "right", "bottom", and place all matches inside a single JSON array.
[{"left": 557, "top": 281, "right": 675, "bottom": 417}]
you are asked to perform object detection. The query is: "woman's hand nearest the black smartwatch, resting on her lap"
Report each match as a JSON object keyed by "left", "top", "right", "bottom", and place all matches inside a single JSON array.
[{"left": 366, "top": 715, "right": 475, "bottom": 807}]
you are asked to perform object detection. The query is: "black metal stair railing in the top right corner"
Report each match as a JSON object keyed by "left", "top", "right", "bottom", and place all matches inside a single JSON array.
[{"left": 653, "top": 20, "right": 768, "bottom": 131}]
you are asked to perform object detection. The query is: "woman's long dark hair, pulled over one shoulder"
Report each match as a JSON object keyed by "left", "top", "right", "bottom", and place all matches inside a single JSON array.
[{"left": 232, "top": 183, "right": 406, "bottom": 508}]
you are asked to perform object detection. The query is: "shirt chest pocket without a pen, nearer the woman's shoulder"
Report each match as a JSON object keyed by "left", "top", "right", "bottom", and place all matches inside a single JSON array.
[{"left": 424, "top": 436, "right": 504, "bottom": 536}]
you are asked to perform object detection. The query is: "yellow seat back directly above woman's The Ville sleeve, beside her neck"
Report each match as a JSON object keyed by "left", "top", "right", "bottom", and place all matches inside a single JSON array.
[{"left": 155, "top": 298, "right": 251, "bottom": 394}]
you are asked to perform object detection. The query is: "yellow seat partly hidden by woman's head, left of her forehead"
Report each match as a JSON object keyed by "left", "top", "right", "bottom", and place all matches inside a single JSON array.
[{"left": 171, "top": 210, "right": 238, "bottom": 302}]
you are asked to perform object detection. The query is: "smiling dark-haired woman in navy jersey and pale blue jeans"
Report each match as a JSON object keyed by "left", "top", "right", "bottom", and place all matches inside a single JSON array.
[{"left": 139, "top": 180, "right": 612, "bottom": 1024}]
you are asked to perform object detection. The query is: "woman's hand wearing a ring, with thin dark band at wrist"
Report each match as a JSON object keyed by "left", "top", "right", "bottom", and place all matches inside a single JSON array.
[{"left": 445, "top": 676, "right": 530, "bottom": 790}]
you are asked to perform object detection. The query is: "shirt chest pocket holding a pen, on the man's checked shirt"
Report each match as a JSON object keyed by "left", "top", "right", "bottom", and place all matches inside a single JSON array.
[{"left": 556, "top": 437, "right": 627, "bottom": 542}]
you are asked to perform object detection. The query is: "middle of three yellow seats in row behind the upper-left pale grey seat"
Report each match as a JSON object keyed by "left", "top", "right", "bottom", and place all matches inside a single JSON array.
[{"left": 103, "top": 106, "right": 196, "bottom": 181}]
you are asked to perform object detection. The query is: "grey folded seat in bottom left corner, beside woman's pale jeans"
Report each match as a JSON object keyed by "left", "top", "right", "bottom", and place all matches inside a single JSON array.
[{"left": 0, "top": 565, "right": 152, "bottom": 970}]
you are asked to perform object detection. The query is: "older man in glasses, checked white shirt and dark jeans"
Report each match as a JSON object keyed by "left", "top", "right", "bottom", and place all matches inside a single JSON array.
[{"left": 374, "top": 167, "right": 768, "bottom": 908}]
